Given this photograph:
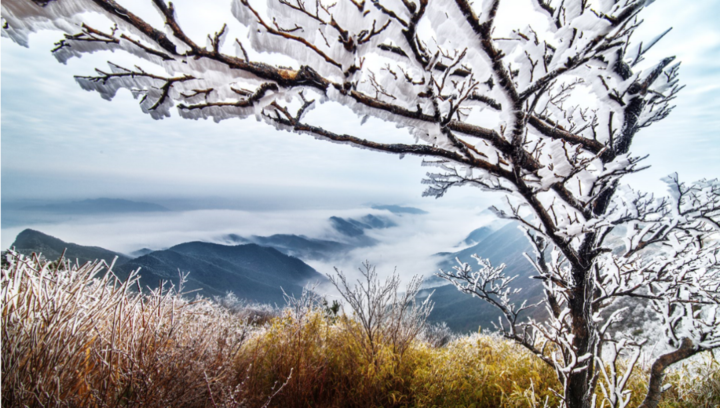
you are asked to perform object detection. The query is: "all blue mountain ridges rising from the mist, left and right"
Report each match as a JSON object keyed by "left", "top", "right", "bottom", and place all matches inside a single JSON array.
[{"left": 7, "top": 209, "right": 543, "bottom": 332}]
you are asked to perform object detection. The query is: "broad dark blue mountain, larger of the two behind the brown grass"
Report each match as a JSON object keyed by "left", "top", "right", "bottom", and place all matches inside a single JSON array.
[{"left": 120, "top": 242, "right": 326, "bottom": 304}]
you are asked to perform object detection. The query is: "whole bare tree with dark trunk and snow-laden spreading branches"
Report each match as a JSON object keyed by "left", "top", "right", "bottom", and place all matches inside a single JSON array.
[{"left": 2, "top": 0, "right": 718, "bottom": 408}]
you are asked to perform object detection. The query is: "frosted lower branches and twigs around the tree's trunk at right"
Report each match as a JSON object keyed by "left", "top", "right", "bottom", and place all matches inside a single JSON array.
[{"left": 440, "top": 175, "right": 720, "bottom": 407}]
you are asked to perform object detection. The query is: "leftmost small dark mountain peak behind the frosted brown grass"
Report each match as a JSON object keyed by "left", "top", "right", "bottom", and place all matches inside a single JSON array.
[{"left": 12, "top": 229, "right": 130, "bottom": 265}]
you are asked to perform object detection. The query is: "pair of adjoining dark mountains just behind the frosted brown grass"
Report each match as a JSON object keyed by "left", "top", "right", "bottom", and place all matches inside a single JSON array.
[{"left": 13, "top": 229, "right": 327, "bottom": 304}]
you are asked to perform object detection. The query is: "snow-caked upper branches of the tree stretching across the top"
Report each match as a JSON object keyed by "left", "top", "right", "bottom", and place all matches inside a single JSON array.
[{"left": 2, "top": 0, "right": 680, "bottom": 180}]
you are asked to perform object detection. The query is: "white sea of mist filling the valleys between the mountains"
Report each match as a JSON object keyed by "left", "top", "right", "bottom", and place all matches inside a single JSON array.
[{"left": 2, "top": 200, "right": 506, "bottom": 281}]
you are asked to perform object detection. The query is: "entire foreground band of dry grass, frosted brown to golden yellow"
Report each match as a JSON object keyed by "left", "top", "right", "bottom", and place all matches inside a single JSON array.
[{"left": 0, "top": 253, "right": 720, "bottom": 408}]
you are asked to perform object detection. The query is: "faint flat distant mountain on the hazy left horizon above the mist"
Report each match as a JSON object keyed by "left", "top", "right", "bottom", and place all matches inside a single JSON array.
[{"left": 23, "top": 198, "right": 170, "bottom": 214}]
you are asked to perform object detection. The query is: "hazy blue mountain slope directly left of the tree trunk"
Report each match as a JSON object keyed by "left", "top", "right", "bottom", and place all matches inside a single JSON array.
[{"left": 421, "top": 223, "right": 544, "bottom": 332}]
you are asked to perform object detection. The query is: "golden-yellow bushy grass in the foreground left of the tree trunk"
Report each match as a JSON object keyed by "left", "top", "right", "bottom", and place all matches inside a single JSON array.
[{"left": 236, "top": 310, "right": 558, "bottom": 408}]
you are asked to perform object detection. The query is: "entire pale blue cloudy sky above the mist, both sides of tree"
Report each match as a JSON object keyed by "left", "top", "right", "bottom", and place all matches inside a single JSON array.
[{"left": 0, "top": 0, "right": 720, "bottom": 256}]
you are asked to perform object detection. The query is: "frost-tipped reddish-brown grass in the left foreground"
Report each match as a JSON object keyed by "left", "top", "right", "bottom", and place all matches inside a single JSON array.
[{"left": 0, "top": 250, "right": 255, "bottom": 407}]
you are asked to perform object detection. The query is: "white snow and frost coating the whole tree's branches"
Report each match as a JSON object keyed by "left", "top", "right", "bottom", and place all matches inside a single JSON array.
[{"left": 2, "top": 0, "right": 720, "bottom": 406}]
